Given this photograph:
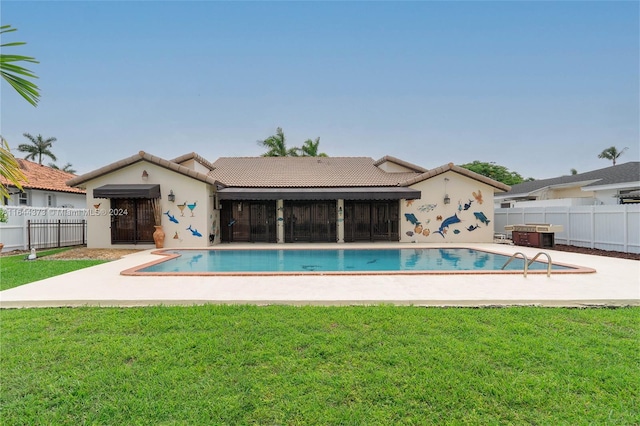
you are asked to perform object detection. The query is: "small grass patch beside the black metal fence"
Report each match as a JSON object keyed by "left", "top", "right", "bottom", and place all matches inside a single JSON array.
[{"left": 0, "top": 248, "right": 105, "bottom": 291}]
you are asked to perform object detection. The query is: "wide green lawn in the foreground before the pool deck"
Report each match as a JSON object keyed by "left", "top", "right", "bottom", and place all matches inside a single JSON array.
[{"left": 0, "top": 305, "right": 640, "bottom": 425}]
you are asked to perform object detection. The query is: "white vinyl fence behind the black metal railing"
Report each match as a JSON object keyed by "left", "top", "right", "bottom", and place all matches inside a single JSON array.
[{"left": 0, "top": 206, "right": 88, "bottom": 252}]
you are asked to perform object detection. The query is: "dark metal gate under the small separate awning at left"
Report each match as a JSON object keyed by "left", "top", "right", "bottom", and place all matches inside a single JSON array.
[{"left": 111, "top": 198, "right": 155, "bottom": 244}]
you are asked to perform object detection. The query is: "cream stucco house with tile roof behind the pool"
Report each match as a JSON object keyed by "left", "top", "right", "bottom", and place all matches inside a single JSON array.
[{"left": 67, "top": 151, "right": 509, "bottom": 248}]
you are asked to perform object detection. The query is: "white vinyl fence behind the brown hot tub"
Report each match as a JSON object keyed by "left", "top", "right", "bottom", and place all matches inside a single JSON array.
[{"left": 494, "top": 204, "right": 640, "bottom": 253}]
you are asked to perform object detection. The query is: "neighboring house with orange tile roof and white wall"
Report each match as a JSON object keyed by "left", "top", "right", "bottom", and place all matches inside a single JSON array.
[{"left": 0, "top": 158, "right": 86, "bottom": 208}]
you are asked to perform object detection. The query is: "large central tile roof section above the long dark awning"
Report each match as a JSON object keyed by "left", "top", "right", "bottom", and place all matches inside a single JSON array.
[{"left": 209, "top": 157, "right": 420, "bottom": 188}]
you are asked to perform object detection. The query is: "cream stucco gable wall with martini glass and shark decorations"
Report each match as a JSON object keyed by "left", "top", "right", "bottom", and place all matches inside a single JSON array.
[{"left": 81, "top": 161, "right": 215, "bottom": 248}]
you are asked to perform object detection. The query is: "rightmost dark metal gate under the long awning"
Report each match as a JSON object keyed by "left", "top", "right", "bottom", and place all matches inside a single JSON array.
[{"left": 344, "top": 201, "right": 400, "bottom": 242}]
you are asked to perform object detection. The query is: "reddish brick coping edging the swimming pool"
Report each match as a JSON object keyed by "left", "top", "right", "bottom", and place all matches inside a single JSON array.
[{"left": 120, "top": 244, "right": 596, "bottom": 277}]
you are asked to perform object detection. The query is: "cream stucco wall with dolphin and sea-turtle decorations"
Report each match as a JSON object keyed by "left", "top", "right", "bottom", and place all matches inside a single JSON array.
[{"left": 400, "top": 171, "right": 494, "bottom": 243}]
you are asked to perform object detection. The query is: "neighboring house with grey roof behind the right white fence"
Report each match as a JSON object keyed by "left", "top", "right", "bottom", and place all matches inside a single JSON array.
[{"left": 494, "top": 161, "right": 640, "bottom": 208}]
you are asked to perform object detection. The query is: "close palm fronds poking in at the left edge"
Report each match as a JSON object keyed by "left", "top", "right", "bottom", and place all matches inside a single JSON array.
[{"left": 0, "top": 25, "right": 40, "bottom": 198}]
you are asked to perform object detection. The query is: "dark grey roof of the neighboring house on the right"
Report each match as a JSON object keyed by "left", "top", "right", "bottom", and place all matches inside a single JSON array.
[{"left": 496, "top": 161, "right": 640, "bottom": 199}]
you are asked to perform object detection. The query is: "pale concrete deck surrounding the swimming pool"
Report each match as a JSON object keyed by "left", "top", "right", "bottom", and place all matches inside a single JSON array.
[{"left": 0, "top": 243, "right": 640, "bottom": 308}]
